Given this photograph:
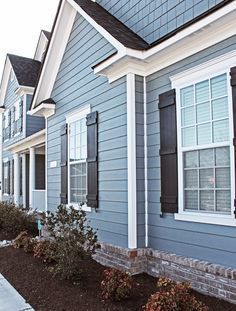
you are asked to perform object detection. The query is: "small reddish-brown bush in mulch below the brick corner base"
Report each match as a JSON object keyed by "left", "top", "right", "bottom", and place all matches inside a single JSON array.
[{"left": 101, "top": 268, "right": 134, "bottom": 301}]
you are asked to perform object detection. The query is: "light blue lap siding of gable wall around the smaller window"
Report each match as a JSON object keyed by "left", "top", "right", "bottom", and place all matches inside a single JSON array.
[{"left": 47, "top": 15, "right": 128, "bottom": 246}]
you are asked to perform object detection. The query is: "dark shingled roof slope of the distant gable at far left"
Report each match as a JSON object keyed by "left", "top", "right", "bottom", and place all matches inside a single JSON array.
[{"left": 7, "top": 54, "right": 41, "bottom": 87}]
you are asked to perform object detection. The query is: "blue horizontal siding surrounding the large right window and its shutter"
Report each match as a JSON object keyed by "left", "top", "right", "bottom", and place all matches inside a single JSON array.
[{"left": 147, "top": 36, "right": 236, "bottom": 267}]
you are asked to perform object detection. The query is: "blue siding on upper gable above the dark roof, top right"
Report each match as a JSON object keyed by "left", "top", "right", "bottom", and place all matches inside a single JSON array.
[{"left": 96, "top": 0, "right": 223, "bottom": 43}]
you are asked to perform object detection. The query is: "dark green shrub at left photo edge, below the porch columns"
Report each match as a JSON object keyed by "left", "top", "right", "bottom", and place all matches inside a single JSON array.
[{"left": 0, "top": 202, "right": 38, "bottom": 237}]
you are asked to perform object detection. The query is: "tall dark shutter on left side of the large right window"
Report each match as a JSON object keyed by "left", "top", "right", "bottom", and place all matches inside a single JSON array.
[{"left": 159, "top": 89, "right": 178, "bottom": 213}]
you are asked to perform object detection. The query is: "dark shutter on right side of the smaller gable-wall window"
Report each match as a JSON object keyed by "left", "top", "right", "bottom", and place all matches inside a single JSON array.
[{"left": 86, "top": 111, "right": 98, "bottom": 208}]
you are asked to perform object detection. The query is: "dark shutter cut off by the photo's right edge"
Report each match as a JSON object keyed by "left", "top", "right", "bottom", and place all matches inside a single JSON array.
[{"left": 230, "top": 67, "right": 236, "bottom": 218}]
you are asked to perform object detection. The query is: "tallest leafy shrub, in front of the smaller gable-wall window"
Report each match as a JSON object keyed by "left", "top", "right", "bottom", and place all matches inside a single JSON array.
[{"left": 47, "top": 205, "right": 97, "bottom": 280}]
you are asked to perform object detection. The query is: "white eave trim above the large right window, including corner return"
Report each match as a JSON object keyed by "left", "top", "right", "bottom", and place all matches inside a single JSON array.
[{"left": 94, "top": 1, "right": 236, "bottom": 82}]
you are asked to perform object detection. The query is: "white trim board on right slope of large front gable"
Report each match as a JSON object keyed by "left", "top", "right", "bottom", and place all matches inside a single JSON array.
[{"left": 67, "top": 0, "right": 126, "bottom": 52}]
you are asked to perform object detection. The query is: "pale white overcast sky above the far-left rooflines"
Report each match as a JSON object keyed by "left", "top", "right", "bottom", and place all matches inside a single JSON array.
[{"left": 0, "top": 0, "right": 59, "bottom": 80}]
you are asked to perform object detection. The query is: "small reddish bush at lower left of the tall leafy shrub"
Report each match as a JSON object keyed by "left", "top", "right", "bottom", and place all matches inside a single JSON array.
[{"left": 33, "top": 240, "right": 57, "bottom": 263}]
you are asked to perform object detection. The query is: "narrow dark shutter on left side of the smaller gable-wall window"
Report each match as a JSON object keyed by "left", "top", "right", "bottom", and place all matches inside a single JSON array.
[{"left": 61, "top": 124, "right": 68, "bottom": 204}]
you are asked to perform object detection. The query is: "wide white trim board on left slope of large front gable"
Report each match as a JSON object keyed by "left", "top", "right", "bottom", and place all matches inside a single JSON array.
[{"left": 32, "top": 0, "right": 77, "bottom": 109}]
